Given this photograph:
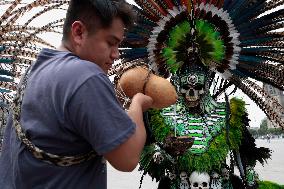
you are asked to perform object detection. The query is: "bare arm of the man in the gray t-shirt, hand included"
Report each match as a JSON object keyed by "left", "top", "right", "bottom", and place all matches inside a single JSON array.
[{"left": 104, "top": 93, "right": 153, "bottom": 172}]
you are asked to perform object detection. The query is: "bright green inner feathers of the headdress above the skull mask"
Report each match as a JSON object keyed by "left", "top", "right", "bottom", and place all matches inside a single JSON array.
[{"left": 162, "top": 20, "right": 225, "bottom": 73}]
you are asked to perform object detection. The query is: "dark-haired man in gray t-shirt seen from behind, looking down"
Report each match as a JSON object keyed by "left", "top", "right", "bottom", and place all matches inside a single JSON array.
[{"left": 0, "top": 0, "right": 152, "bottom": 189}]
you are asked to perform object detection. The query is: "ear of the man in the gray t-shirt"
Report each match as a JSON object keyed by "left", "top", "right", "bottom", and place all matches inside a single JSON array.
[{"left": 71, "top": 21, "right": 87, "bottom": 46}]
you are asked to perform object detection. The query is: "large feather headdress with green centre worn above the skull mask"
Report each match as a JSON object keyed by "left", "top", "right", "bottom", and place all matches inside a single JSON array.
[{"left": 116, "top": 0, "right": 284, "bottom": 128}]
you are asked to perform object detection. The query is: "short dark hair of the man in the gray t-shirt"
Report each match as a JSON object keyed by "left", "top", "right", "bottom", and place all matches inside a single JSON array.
[{"left": 63, "top": 0, "right": 135, "bottom": 40}]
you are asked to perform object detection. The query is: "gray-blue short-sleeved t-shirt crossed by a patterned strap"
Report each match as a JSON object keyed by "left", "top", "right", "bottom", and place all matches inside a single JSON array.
[{"left": 0, "top": 49, "right": 135, "bottom": 189}]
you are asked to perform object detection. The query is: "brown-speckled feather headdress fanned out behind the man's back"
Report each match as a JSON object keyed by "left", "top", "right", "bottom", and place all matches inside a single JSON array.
[{"left": 0, "top": 0, "right": 68, "bottom": 128}]
